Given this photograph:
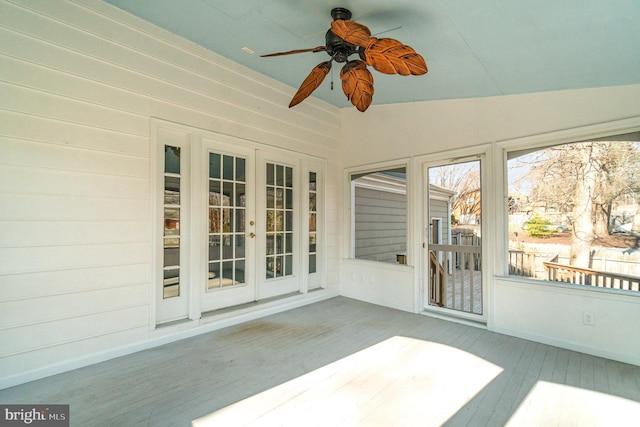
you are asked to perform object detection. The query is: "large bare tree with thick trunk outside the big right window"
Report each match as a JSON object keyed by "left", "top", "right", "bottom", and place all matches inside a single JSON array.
[{"left": 523, "top": 141, "right": 640, "bottom": 267}]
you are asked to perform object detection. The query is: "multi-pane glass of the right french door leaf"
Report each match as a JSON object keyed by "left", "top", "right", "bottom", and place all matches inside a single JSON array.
[{"left": 266, "top": 163, "right": 294, "bottom": 279}]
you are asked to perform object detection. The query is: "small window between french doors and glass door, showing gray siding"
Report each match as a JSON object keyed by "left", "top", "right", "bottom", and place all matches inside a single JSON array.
[{"left": 351, "top": 167, "right": 407, "bottom": 263}]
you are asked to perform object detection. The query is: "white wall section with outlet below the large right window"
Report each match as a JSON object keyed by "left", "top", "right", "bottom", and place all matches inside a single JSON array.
[{"left": 493, "top": 278, "right": 640, "bottom": 365}]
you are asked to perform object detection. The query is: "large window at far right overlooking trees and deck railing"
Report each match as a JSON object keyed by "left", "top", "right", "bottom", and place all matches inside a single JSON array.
[{"left": 507, "top": 137, "right": 640, "bottom": 291}]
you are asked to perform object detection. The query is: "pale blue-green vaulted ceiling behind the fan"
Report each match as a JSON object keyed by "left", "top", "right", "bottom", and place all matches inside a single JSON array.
[{"left": 105, "top": 0, "right": 640, "bottom": 107}]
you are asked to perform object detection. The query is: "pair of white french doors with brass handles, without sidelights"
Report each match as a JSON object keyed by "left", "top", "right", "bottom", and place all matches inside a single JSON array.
[{"left": 200, "top": 143, "right": 300, "bottom": 312}]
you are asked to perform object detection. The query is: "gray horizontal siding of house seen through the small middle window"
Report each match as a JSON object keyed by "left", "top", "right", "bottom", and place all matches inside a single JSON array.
[{"left": 355, "top": 186, "right": 407, "bottom": 263}]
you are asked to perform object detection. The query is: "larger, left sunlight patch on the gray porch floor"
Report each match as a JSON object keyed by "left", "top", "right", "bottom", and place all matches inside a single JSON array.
[{"left": 192, "top": 336, "right": 502, "bottom": 427}]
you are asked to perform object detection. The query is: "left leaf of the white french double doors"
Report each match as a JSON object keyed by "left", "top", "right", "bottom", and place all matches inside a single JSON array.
[{"left": 200, "top": 138, "right": 262, "bottom": 312}]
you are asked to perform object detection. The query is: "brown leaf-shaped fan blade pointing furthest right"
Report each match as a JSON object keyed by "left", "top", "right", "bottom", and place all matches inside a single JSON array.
[{"left": 364, "top": 37, "right": 428, "bottom": 76}]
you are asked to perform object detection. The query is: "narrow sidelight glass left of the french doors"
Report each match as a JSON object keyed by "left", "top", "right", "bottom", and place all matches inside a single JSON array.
[{"left": 162, "top": 145, "right": 180, "bottom": 298}]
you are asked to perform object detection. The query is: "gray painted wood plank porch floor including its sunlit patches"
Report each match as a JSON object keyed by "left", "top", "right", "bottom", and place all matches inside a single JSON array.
[{"left": 0, "top": 297, "right": 640, "bottom": 426}]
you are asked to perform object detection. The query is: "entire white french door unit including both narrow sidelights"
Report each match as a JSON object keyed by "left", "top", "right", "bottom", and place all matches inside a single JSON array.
[{"left": 154, "top": 122, "right": 308, "bottom": 323}]
